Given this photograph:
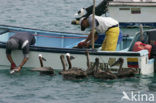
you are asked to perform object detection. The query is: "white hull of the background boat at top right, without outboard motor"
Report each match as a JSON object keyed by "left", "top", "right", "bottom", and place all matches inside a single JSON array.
[{"left": 108, "top": 0, "right": 156, "bottom": 27}]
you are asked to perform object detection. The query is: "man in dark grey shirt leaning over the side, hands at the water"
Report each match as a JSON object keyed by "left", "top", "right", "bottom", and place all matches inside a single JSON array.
[{"left": 6, "top": 32, "right": 35, "bottom": 72}]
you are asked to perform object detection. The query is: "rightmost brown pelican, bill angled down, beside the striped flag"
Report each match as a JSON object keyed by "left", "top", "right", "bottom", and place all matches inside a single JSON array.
[{"left": 111, "top": 58, "right": 136, "bottom": 78}]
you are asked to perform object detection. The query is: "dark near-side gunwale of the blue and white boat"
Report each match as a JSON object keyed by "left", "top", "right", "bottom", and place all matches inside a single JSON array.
[{"left": 0, "top": 43, "right": 141, "bottom": 56}]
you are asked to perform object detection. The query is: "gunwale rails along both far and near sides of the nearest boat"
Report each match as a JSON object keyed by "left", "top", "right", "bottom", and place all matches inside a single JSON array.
[{"left": 0, "top": 25, "right": 147, "bottom": 56}]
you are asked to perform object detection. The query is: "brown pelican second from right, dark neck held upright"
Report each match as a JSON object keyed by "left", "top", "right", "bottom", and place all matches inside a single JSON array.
[{"left": 94, "top": 58, "right": 117, "bottom": 79}]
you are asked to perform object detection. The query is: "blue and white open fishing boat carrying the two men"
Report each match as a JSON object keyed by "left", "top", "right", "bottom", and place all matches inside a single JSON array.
[{"left": 0, "top": 25, "right": 156, "bottom": 74}]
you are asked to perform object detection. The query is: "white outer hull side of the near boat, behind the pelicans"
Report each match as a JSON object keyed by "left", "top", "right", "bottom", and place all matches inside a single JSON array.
[{"left": 0, "top": 48, "right": 154, "bottom": 74}]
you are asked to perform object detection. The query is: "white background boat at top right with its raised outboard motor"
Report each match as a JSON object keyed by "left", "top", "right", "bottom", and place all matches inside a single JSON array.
[{"left": 72, "top": 0, "right": 156, "bottom": 27}]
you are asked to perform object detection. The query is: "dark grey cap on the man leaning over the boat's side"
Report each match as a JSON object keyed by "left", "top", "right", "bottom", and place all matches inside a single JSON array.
[{"left": 6, "top": 38, "right": 19, "bottom": 49}]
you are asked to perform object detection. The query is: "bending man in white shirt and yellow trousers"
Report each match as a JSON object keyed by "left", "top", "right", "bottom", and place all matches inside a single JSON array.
[{"left": 78, "top": 15, "right": 120, "bottom": 51}]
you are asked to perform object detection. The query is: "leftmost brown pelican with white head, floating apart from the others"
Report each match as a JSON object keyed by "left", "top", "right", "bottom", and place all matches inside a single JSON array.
[{"left": 32, "top": 54, "right": 54, "bottom": 75}]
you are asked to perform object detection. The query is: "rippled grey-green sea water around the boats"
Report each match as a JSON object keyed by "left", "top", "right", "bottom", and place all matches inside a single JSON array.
[{"left": 0, "top": 0, "right": 156, "bottom": 103}]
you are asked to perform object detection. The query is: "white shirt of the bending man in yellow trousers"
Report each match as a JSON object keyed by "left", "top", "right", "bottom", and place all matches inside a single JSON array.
[{"left": 88, "top": 15, "right": 119, "bottom": 34}]
